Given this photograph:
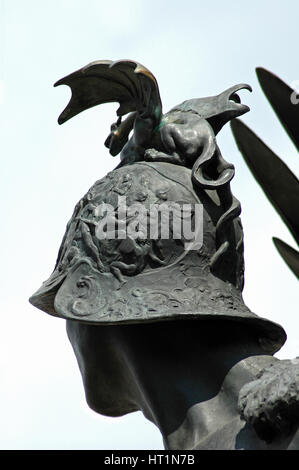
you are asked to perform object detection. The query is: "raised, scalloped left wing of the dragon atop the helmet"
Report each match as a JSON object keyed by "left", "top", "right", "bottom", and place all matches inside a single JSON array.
[{"left": 54, "top": 60, "right": 162, "bottom": 124}]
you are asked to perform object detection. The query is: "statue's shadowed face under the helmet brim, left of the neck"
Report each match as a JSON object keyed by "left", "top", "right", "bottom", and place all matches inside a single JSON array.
[{"left": 66, "top": 320, "right": 143, "bottom": 416}]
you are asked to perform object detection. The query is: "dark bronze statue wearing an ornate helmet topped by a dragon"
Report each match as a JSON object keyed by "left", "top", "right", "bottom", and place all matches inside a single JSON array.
[{"left": 30, "top": 61, "right": 299, "bottom": 449}]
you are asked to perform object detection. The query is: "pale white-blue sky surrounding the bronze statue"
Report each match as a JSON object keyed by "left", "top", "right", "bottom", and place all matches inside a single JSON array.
[{"left": 0, "top": 0, "right": 299, "bottom": 449}]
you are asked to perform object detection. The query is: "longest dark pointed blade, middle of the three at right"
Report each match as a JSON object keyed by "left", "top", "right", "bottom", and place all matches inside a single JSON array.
[{"left": 231, "top": 119, "right": 299, "bottom": 244}]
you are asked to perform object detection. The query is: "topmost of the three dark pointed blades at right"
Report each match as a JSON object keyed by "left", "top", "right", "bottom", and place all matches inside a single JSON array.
[{"left": 256, "top": 67, "right": 299, "bottom": 151}]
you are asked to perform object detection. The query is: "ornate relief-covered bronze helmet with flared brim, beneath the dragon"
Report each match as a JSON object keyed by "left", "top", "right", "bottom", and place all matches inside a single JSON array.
[{"left": 30, "top": 162, "right": 286, "bottom": 354}]
